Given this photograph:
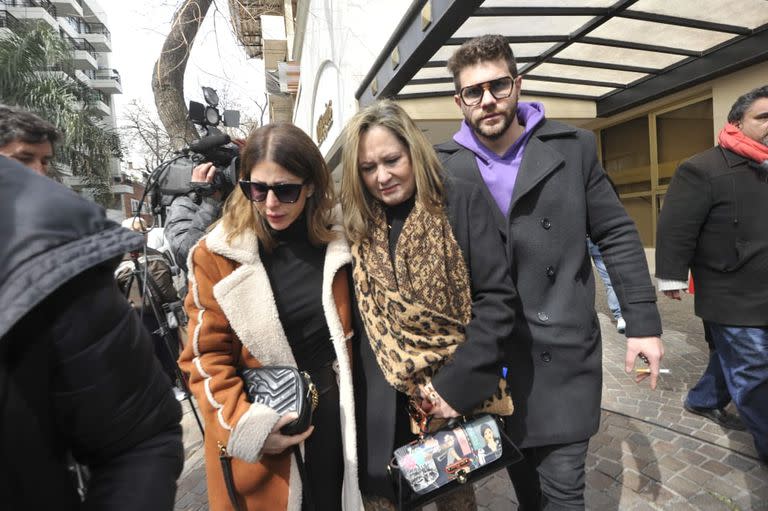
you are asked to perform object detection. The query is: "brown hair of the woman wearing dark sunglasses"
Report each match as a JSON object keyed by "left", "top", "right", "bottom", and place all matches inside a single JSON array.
[{"left": 221, "top": 123, "right": 336, "bottom": 252}]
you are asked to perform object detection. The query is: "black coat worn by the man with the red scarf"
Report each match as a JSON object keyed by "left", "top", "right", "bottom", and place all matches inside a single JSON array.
[{"left": 656, "top": 146, "right": 768, "bottom": 326}]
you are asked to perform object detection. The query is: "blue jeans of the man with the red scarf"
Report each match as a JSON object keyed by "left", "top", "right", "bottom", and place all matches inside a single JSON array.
[{"left": 687, "top": 321, "right": 768, "bottom": 462}]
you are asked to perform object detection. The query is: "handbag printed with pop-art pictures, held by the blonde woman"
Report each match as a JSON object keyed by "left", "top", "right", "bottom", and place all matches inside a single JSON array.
[{"left": 388, "top": 414, "right": 523, "bottom": 511}]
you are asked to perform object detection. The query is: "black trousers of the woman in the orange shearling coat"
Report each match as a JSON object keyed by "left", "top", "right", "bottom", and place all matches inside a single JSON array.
[{"left": 301, "top": 366, "right": 344, "bottom": 511}]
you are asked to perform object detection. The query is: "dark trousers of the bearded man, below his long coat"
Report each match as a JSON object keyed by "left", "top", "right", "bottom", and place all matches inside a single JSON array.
[{"left": 507, "top": 440, "right": 589, "bottom": 511}]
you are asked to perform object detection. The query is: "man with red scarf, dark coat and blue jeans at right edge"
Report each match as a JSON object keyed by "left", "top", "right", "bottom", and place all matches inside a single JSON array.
[{"left": 656, "top": 85, "right": 768, "bottom": 462}]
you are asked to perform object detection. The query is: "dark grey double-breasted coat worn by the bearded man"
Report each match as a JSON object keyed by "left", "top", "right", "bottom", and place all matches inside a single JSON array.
[{"left": 436, "top": 120, "right": 661, "bottom": 447}]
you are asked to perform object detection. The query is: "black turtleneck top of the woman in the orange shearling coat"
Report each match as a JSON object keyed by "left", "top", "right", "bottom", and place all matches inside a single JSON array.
[{"left": 260, "top": 215, "right": 336, "bottom": 371}]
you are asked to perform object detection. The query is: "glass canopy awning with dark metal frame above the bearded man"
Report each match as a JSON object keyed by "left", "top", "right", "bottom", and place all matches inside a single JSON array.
[{"left": 357, "top": 0, "right": 768, "bottom": 117}]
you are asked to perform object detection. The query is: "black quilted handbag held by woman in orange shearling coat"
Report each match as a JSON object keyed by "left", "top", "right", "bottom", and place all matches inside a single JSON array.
[{"left": 238, "top": 366, "right": 318, "bottom": 435}]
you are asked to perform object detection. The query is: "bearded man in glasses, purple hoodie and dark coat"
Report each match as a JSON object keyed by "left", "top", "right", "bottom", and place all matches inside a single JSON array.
[{"left": 437, "top": 36, "right": 663, "bottom": 511}]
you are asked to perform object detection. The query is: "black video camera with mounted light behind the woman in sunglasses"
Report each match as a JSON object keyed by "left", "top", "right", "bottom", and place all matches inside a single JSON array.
[{"left": 152, "top": 87, "right": 240, "bottom": 214}]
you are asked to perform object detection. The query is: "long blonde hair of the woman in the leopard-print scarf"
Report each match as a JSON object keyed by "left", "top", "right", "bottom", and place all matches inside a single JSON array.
[{"left": 341, "top": 100, "right": 443, "bottom": 242}]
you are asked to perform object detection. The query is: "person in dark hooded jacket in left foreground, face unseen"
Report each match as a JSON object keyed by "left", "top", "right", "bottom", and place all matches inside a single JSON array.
[{"left": 0, "top": 157, "right": 183, "bottom": 511}]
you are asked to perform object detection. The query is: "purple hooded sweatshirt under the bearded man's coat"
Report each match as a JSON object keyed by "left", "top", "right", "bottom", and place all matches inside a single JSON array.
[{"left": 453, "top": 102, "right": 544, "bottom": 218}]
